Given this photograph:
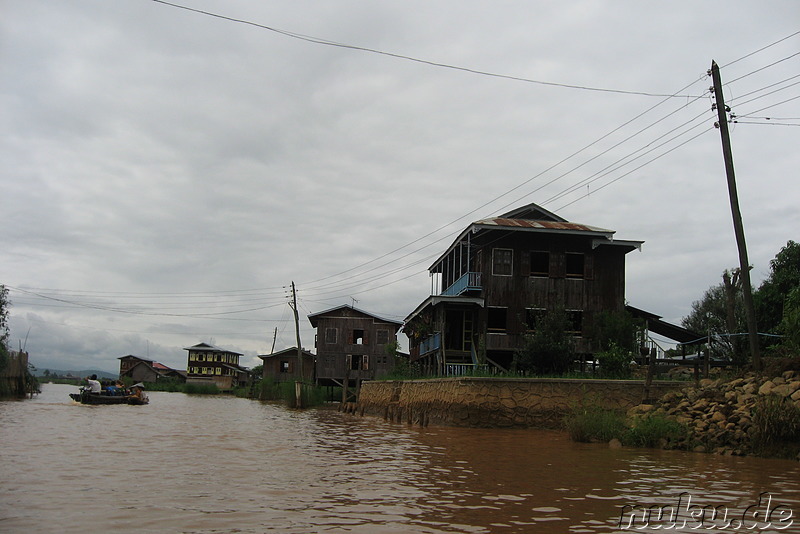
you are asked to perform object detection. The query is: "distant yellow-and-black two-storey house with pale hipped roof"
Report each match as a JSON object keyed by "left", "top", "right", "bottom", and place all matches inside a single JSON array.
[{"left": 183, "top": 343, "right": 249, "bottom": 390}]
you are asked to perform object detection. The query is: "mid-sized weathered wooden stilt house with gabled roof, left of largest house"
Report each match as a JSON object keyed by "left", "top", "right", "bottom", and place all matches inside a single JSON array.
[{"left": 308, "top": 305, "right": 403, "bottom": 385}]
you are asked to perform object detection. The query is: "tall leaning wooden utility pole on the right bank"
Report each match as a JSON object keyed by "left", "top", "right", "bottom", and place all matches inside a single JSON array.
[{"left": 709, "top": 60, "right": 761, "bottom": 370}]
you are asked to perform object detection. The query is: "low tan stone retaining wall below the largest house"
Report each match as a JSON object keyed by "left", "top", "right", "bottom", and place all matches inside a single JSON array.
[{"left": 350, "top": 378, "right": 687, "bottom": 428}]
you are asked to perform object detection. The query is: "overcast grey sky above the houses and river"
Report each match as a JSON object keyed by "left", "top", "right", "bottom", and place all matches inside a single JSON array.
[{"left": 0, "top": 0, "right": 800, "bottom": 371}]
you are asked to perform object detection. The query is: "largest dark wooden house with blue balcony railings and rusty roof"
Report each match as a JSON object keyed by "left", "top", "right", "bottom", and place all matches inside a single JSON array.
[{"left": 404, "top": 204, "right": 642, "bottom": 374}]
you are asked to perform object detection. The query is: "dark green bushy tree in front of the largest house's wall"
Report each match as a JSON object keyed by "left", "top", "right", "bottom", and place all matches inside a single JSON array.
[{"left": 514, "top": 310, "right": 574, "bottom": 374}]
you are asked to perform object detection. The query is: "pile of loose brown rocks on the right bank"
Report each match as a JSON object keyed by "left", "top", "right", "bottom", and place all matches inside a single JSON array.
[{"left": 628, "top": 371, "right": 800, "bottom": 459}]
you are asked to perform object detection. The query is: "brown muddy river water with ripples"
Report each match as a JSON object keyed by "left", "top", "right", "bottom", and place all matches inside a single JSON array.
[{"left": 0, "top": 384, "right": 800, "bottom": 534}]
